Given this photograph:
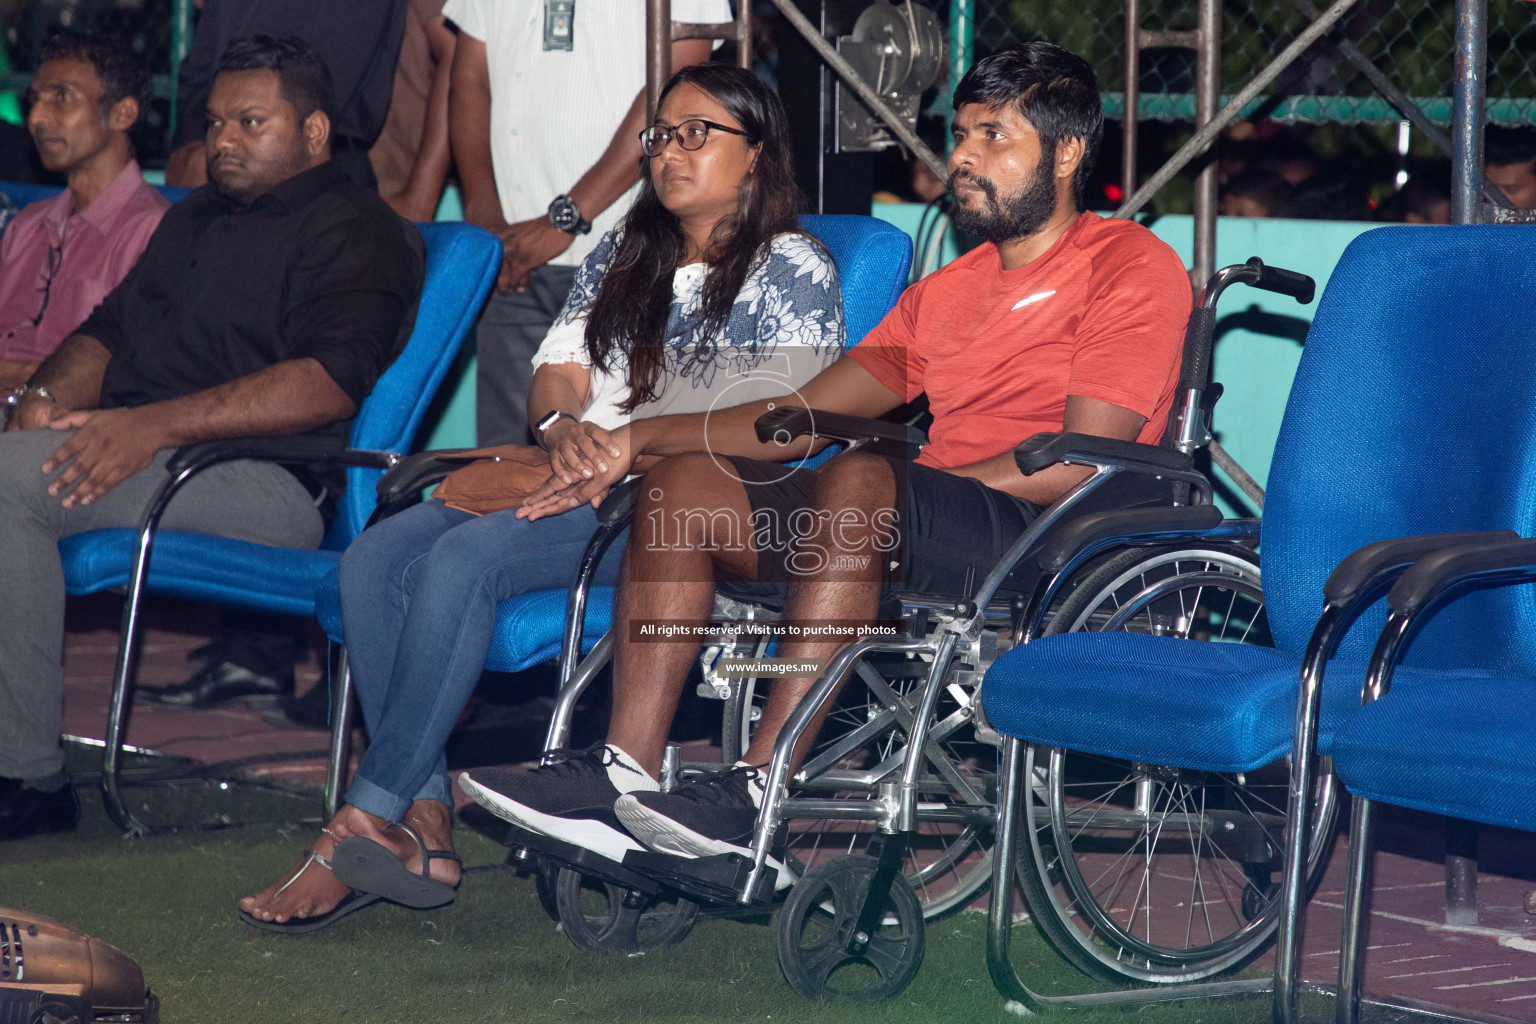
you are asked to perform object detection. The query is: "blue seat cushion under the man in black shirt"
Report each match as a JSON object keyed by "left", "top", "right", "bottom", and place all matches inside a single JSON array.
[{"left": 58, "top": 530, "right": 341, "bottom": 617}]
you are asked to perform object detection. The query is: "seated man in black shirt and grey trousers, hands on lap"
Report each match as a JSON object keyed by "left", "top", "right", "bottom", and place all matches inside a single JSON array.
[{"left": 0, "top": 37, "right": 424, "bottom": 840}]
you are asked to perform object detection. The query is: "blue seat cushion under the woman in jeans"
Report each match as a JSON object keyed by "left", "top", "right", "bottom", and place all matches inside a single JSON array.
[{"left": 315, "top": 570, "right": 613, "bottom": 672}]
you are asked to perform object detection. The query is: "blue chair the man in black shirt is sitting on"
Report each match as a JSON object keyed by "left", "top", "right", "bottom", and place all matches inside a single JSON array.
[{"left": 58, "top": 224, "right": 501, "bottom": 832}]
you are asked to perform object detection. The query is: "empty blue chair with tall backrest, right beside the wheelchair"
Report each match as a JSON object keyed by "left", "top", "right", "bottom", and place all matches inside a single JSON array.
[{"left": 983, "top": 227, "right": 1536, "bottom": 1024}]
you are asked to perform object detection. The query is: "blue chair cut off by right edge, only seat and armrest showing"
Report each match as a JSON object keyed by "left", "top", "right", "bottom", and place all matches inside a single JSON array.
[{"left": 1333, "top": 537, "right": 1536, "bottom": 1024}]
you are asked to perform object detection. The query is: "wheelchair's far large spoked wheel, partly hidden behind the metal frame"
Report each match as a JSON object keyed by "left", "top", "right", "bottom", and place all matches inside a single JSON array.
[{"left": 780, "top": 657, "right": 997, "bottom": 918}]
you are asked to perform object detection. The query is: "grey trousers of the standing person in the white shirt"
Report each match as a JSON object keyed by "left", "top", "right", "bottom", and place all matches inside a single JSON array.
[{"left": 475, "top": 266, "right": 576, "bottom": 447}]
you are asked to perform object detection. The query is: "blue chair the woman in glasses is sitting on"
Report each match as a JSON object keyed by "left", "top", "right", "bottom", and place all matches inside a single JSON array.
[{"left": 316, "top": 215, "right": 912, "bottom": 779}]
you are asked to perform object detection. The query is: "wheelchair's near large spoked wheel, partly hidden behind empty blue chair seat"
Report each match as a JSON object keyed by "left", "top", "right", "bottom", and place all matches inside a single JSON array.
[{"left": 1018, "top": 547, "right": 1335, "bottom": 983}]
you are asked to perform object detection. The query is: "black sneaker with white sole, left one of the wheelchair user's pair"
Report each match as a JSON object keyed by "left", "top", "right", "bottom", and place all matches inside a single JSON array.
[{"left": 459, "top": 743, "right": 656, "bottom": 861}]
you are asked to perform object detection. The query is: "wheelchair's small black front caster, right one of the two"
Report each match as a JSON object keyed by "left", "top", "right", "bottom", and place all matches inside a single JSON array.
[{"left": 779, "top": 857, "right": 923, "bottom": 1001}]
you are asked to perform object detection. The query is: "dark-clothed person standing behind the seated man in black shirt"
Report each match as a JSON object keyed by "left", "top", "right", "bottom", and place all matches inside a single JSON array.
[{"left": 166, "top": 0, "right": 407, "bottom": 187}]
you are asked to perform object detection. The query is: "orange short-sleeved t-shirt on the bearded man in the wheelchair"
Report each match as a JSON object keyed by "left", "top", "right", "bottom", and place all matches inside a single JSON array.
[{"left": 848, "top": 212, "right": 1190, "bottom": 468}]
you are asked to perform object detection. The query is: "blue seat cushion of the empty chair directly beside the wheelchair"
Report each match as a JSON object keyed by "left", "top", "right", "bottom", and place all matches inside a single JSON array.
[{"left": 982, "top": 633, "right": 1366, "bottom": 772}]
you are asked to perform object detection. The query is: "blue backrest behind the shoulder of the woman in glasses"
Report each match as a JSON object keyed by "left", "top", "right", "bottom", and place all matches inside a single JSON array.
[{"left": 800, "top": 213, "right": 912, "bottom": 348}]
